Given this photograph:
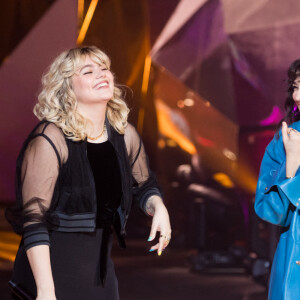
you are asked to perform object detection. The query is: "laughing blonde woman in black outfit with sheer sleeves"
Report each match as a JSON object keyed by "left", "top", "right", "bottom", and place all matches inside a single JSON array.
[{"left": 6, "top": 46, "right": 171, "bottom": 300}]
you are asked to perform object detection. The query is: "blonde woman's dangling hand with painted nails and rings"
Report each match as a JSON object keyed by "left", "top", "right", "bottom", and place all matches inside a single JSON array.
[{"left": 147, "top": 197, "right": 172, "bottom": 255}]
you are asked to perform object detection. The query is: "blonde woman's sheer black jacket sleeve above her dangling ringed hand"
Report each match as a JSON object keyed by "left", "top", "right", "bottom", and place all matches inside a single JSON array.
[{"left": 125, "top": 124, "right": 161, "bottom": 213}]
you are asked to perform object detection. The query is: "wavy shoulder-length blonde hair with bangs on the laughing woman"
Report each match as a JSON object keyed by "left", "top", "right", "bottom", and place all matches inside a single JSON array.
[{"left": 33, "top": 46, "right": 129, "bottom": 141}]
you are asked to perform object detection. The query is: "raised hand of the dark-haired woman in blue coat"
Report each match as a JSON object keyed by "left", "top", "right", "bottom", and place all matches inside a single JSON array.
[{"left": 282, "top": 122, "right": 300, "bottom": 177}]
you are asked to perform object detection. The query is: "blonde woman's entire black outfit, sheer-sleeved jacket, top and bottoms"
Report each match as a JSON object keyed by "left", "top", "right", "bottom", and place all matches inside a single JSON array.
[{"left": 7, "top": 121, "right": 160, "bottom": 300}]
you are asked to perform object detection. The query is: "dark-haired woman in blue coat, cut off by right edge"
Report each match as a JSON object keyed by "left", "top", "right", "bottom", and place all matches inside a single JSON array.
[{"left": 255, "top": 60, "right": 300, "bottom": 300}]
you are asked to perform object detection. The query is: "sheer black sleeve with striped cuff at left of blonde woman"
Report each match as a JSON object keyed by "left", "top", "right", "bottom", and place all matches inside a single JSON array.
[{"left": 6, "top": 123, "right": 68, "bottom": 250}]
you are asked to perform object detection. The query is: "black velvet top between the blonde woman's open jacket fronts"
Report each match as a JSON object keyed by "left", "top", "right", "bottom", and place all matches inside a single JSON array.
[{"left": 87, "top": 141, "right": 122, "bottom": 228}]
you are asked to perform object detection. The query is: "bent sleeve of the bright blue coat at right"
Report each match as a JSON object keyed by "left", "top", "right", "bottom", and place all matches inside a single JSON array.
[{"left": 254, "top": 131, "right": 299, "bottom": 227}]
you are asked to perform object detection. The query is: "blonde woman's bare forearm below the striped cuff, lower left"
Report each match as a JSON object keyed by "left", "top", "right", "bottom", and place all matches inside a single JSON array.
[{"left": 26, "top": 245, "right": 55, "bottom": 297}]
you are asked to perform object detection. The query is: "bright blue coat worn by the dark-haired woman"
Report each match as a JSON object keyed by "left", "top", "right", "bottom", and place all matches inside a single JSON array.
[{"left": 255, "top": 122, "right": 300, "bottom": 300}]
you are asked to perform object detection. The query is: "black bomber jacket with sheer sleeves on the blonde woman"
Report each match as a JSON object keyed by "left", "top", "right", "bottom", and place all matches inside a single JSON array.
[{"left": 6, "top": 119, "right": 161, "bottom": 250}]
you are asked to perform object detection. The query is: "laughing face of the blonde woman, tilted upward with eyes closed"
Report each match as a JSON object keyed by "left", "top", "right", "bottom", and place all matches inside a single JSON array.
[{"left": 72, "top": 55, "right": 114, "bottom": 104}]
